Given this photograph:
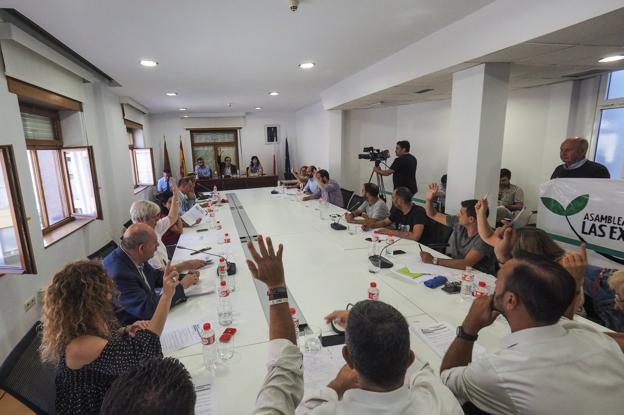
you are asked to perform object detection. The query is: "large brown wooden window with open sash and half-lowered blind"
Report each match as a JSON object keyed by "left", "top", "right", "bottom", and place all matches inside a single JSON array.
[{"left": 20, "top": 105, "right": 102, "bottom": 234}]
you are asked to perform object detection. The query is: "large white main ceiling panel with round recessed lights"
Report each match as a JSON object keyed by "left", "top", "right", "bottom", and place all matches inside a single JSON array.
[{"left": 0, "top": 0, "right": 494, "bottom": 113}]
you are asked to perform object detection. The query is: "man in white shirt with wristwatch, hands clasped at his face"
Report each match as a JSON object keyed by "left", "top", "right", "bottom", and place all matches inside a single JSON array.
[{"left": 440, "top": 254, "right": 624, "bottom": 415}]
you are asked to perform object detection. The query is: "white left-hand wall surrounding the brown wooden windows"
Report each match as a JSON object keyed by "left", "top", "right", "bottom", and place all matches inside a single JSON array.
[{"left": 0, "top": 75, "right": 151, "bottom": 362}]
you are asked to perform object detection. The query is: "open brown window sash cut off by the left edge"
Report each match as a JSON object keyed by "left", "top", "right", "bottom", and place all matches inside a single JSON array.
[{"left": 0, "top": 146, "right": 37, "bottom": 274}]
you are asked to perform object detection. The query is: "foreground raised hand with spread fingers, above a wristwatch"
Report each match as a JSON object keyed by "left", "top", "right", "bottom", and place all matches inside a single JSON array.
[{"left": 247, "top": 235, "right": 286, "bottom": 288}]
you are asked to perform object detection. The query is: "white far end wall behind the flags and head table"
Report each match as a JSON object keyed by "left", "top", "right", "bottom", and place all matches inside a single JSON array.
[{"left": 149, "top": 112, "right": 297, "bottom": 178}]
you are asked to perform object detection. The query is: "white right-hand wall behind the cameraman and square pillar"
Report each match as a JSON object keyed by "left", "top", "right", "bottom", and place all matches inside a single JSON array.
[{"left": 332, "top": 78, "right": 598, "bottom": 209}]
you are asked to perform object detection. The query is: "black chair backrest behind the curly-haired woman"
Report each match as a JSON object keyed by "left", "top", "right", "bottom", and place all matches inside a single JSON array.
[{"left": 0, "top": 322, "right": 56, "bottom": 414}]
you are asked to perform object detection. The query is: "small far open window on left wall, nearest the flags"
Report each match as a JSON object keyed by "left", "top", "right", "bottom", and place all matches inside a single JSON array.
[{"left": 125, "top": 120, "right": 156, "bottom": 193}]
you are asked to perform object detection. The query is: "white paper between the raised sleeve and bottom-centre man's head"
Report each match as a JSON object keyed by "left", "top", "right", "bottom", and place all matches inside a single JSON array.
[{"left": 303, "top": 345, "right": 345, "bottom": 394}]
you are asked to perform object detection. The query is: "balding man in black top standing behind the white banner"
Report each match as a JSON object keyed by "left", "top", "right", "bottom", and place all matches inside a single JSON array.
[{"left": 550, "top": 138, "right": 611, "bottom": 179}]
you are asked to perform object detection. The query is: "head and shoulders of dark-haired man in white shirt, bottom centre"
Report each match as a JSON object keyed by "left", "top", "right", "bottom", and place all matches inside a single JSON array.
[{"left": 296, "top": 300, "right": 463, "bottom": 415}]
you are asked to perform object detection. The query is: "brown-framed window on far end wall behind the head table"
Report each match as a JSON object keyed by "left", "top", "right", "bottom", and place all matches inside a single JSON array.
[{"left": 191, "top": 129, "right": 239, "bottom": 176}]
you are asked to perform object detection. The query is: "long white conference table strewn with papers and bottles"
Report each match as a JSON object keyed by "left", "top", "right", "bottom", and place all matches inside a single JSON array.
[{"left": 164, "top": 188, "right": 606, "bottom": 414}]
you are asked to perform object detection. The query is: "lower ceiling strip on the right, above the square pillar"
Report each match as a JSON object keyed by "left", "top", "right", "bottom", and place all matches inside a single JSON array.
[{"left": 337, "top": 8, "right": 624, "bottom": 110}]
